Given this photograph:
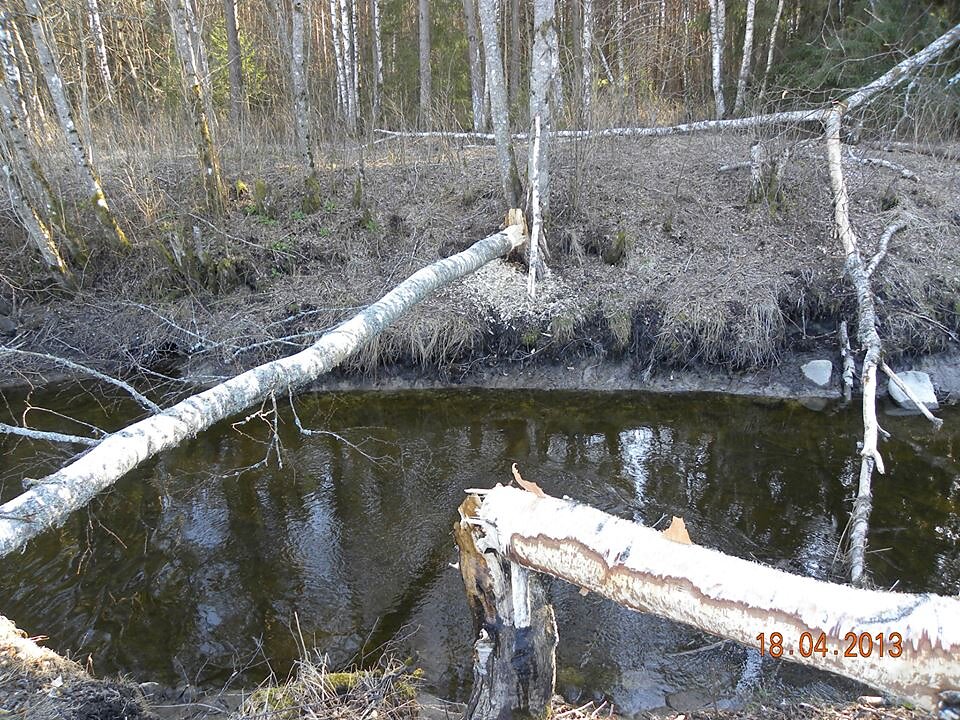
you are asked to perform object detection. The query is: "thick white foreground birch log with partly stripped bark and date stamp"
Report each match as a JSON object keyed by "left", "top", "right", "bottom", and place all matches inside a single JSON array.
[{"left": 471, "top": 486, "right": 960, "bottom": 709}]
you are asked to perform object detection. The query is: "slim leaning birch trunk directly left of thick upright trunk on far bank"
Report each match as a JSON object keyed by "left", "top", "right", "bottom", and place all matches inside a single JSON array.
[{"left": 478, "top": 0, "right": 523, "bottom": 208}]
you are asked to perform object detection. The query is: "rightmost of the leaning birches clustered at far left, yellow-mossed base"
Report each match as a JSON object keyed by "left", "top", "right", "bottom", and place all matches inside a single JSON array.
[{"left": 24, "top": 0, "right": 130, "bottom": 249}]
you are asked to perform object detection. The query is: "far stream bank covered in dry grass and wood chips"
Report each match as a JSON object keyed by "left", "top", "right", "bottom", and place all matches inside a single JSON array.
[{"left": 0, "top": 134, "right": 960, "bottom": 395}]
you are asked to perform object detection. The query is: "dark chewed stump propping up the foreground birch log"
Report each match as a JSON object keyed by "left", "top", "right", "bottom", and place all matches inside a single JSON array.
[{"left": 453, "top": 495, "right": 557, "bottom": 720}]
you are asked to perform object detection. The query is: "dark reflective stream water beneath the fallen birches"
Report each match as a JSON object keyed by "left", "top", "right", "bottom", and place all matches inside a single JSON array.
[{"left": 0, "top": 388, "right": 960, "bottom": 712}]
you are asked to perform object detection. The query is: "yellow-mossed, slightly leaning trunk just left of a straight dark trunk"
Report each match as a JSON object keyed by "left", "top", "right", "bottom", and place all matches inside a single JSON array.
[{"left": 167, "top": 0, "right": 226, "bottom": 215}]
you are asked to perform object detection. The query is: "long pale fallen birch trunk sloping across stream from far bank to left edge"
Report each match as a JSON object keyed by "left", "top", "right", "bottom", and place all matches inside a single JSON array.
[{"left": 0, "top": 224, "right": 526, "bottom": 557}]
